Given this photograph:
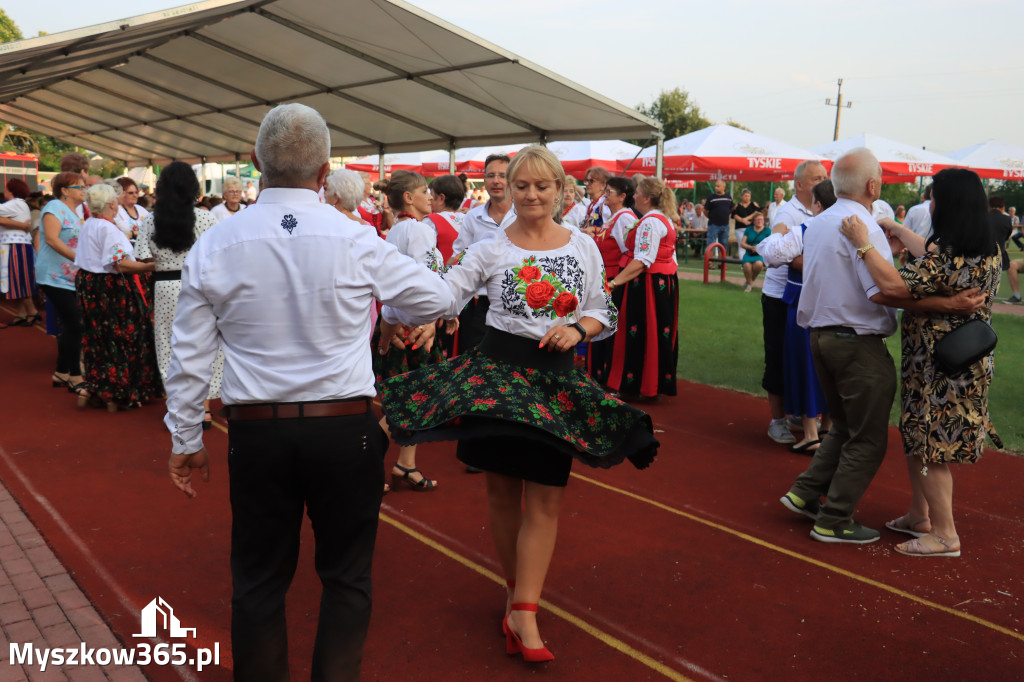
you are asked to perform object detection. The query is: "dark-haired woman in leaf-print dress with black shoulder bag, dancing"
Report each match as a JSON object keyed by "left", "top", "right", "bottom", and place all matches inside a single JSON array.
[{"left": 842, "top": 168, "right": 1002, "bottom": 557}]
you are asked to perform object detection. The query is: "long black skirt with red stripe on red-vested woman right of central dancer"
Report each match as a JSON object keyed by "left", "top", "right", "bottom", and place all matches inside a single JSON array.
[{"left": 607, "top": 272, "right": 679, "bottom": 397}]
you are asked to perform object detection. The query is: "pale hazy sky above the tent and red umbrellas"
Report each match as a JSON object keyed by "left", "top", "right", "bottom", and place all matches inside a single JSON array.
[{"left": 8, "top": 0, "right": 1024, "bottom": 154}]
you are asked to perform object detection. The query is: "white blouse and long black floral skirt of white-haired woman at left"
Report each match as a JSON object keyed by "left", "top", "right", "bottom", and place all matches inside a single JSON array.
[{"left": 75, "top": 216, "right": 164, "bottom": 406}]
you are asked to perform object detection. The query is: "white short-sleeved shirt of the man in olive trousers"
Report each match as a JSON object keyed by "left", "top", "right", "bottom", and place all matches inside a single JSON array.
[{"left": 797, "top": 199, "right": 896, "bottom": 336}]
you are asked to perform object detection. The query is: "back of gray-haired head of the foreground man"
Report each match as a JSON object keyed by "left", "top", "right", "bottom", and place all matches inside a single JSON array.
[{"left": 256, "top": 102, "right": 331, "bottom": 187}]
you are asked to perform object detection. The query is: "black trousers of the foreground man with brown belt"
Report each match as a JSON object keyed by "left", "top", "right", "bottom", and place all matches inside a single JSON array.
[{"left": 227, "top": 414, "right": 388, "bottom": 682}]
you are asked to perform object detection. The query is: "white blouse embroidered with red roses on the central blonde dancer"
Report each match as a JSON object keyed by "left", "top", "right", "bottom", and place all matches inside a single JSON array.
[{"left": 381, "top": 229, "right": 617, "bottom": 341}]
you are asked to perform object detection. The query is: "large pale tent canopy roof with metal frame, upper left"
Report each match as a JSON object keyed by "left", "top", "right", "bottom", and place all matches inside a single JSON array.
[{"left": 0, "top": 0, "right": 658, "bottom": 164}]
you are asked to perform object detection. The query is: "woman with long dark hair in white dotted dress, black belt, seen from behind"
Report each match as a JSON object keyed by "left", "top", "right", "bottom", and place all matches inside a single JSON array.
[{"left": 135, "top": 161, "right": 224, "bottom": 428}]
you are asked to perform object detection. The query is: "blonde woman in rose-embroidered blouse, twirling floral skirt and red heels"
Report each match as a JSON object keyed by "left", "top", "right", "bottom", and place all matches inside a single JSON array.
[{"left": 380, "top": 146, "right": 657, "bottom": 662}]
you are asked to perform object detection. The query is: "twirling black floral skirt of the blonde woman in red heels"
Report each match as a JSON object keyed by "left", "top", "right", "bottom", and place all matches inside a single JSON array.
[{"left": 378, "top": 328, "right": 658, "bottom": 485}]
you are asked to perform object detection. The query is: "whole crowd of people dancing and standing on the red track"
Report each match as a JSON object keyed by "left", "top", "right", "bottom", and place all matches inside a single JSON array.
[{"left": 0, "top": 104, "right": 1017, "bottom": 680}]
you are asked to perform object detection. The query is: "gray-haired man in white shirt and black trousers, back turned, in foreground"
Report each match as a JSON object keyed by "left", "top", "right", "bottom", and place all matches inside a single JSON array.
[{"left": 164, "top": 103, "right": 454, "bottom": 680}]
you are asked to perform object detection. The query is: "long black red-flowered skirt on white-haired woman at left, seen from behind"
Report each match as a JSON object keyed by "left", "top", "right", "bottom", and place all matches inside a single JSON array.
[{"left": 75, "top": 269, "right": 164, "bottom": 407}]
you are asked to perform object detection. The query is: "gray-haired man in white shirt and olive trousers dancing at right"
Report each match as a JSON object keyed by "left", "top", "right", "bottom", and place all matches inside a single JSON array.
[{"left": 779, "top": 148, "right": 984, "bottom": 545}]
